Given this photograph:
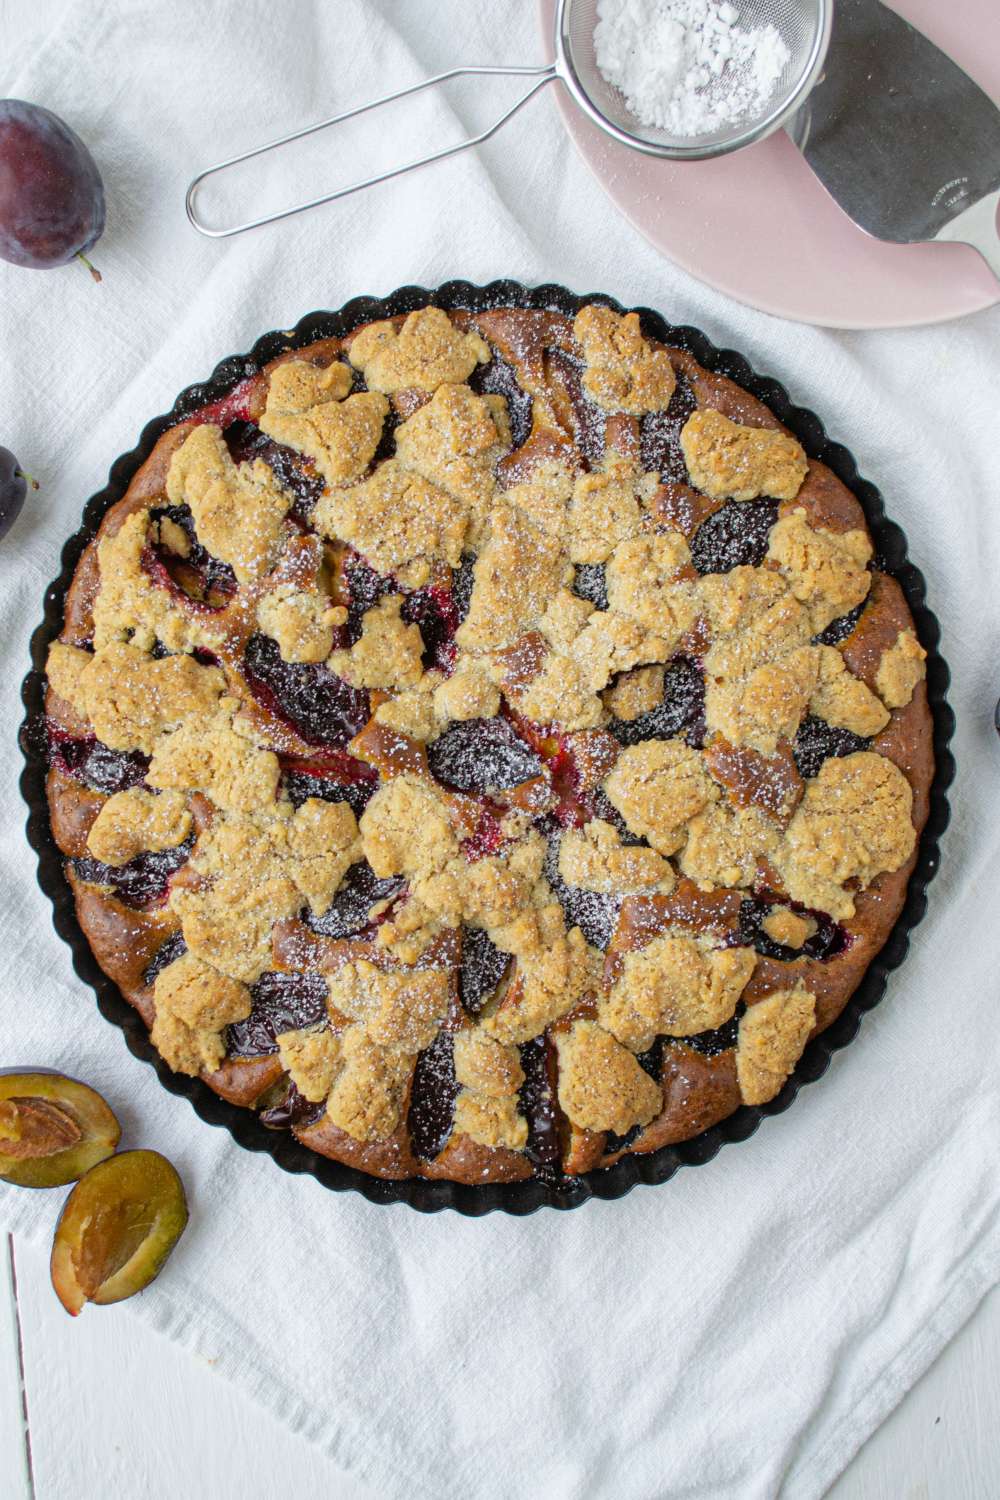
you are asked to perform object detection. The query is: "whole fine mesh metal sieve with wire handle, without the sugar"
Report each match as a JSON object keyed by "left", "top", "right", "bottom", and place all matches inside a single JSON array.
[{"left": 184, "top": 0, "right": 834, "bottom": 239}]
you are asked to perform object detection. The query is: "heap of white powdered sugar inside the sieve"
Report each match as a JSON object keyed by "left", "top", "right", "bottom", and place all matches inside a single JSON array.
[{"left": 594, "top": 0, "right": 790, "bottom": 137}]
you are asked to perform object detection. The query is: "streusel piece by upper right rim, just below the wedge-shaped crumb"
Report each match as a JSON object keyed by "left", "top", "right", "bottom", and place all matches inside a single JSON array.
[{"left": 768, "top": 510, "right": 871, "bottom": 632}]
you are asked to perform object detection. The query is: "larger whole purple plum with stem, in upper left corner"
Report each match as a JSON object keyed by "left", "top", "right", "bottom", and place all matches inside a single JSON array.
[{"left": 0, "top": 99, "right": 105, "bottom": 270}]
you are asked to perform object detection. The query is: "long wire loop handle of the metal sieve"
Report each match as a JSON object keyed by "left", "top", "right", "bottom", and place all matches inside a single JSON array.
[{"left": 184, "top": 63, "right": 558, "bottom": 240}]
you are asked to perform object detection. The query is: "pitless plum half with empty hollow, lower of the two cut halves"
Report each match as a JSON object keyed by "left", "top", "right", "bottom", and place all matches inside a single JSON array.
[{"left": 51, "top": 1151, "right": 187, "bottom": 1317}]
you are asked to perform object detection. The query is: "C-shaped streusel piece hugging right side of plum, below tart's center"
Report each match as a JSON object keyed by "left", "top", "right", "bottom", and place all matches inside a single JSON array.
[{"left": 481, "top": 902, "right": 595, "bottom": 1044}]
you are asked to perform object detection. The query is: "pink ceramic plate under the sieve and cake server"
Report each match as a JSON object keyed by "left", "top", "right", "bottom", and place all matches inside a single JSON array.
[{"left": 540, "top": 0, "right": 1000, "bottom": 329}]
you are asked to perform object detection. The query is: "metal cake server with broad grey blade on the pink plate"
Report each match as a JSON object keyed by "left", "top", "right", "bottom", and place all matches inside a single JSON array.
[{"left": 787, "top": 0, "right": 1000, "bottom": 278}]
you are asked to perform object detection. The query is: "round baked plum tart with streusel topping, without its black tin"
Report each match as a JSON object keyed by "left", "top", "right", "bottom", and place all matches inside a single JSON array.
[{"left": 37, "top": 302, "right": 934, "bottom": 1185}]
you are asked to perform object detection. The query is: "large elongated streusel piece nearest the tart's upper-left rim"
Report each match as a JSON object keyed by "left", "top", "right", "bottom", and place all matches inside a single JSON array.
[{"left": 166, "top": 422, "right": 289, "bottom": 584}]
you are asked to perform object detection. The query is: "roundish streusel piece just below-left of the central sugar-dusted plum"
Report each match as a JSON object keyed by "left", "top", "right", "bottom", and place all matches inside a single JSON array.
[{"left": 360, "top": 776, "right": 459, "bottom": 879}]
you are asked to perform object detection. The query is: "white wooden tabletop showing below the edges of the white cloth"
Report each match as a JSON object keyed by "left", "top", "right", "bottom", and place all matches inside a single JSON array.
[{"left": 0, "top": 1241, "right": 1000, "bottom": 1500}]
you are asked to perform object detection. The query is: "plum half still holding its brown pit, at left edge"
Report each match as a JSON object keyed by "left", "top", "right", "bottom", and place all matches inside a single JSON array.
[{"left": 0, "top": 1073, "right": 121, "bottom": 1188}]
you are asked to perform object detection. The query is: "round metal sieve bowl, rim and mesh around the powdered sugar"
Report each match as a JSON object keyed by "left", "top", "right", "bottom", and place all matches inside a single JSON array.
[{"left": 556, "top": 0, "right": 832, "bottom": 156}]
